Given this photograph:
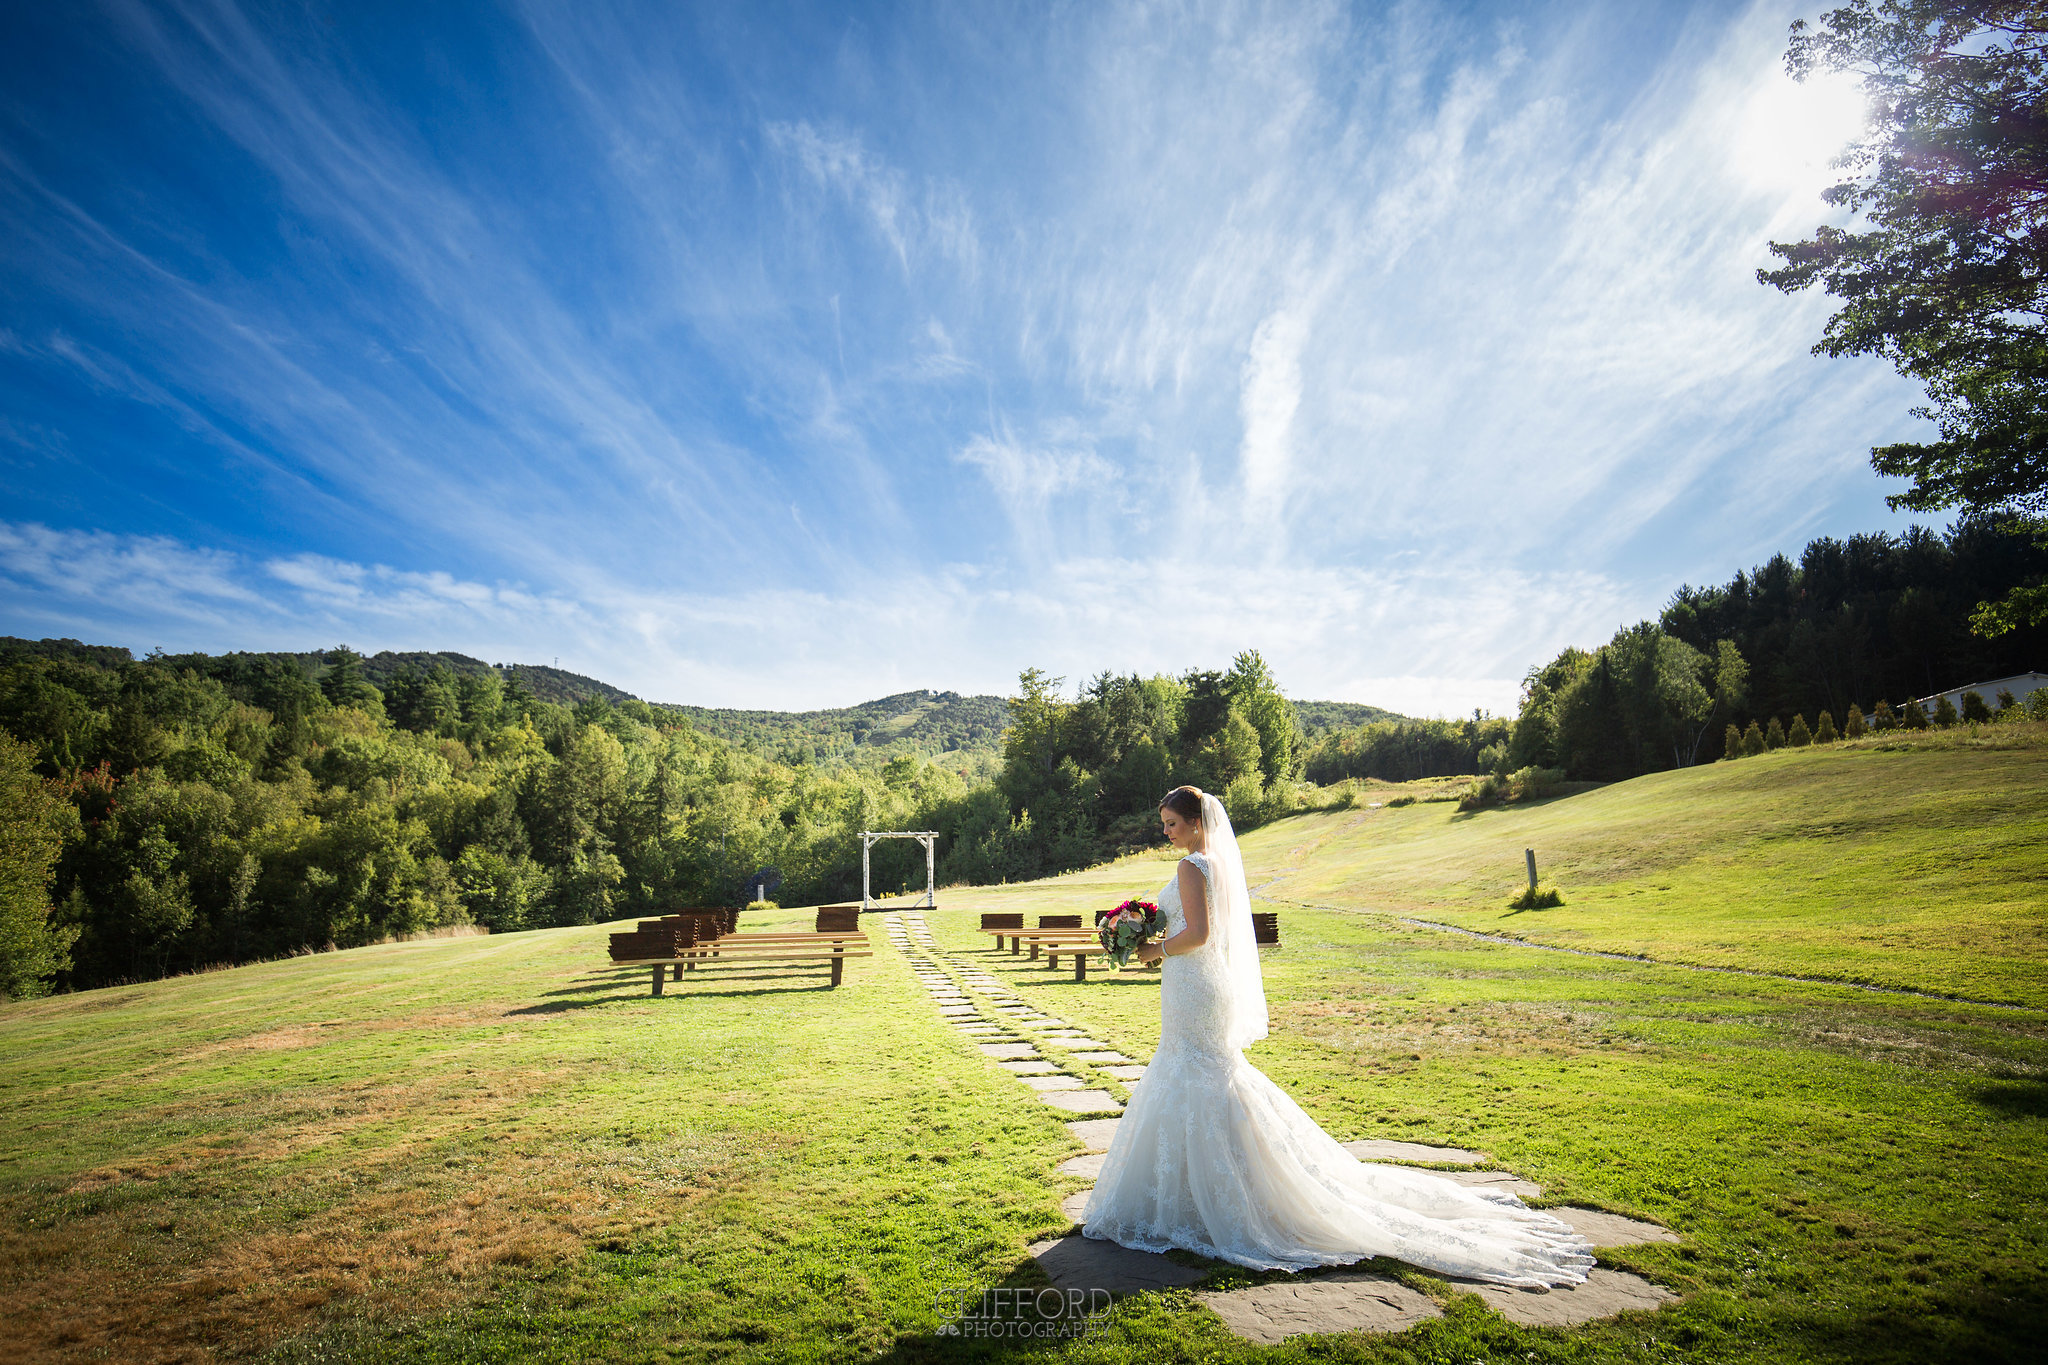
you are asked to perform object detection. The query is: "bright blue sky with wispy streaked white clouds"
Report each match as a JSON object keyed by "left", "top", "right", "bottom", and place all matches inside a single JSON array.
[{"left": 0, "top": 0, "right": 1919, "bottom": 714}]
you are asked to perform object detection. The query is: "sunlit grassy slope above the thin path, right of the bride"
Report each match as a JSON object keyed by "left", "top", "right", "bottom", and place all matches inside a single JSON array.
[{"left": 1247, "top": 726, "right": 2048, "bottom": 1005}]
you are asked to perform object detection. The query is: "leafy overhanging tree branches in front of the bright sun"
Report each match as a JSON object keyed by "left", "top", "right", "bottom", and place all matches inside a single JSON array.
[{"left": 1757, "top": 0, "right": 2048, "bottom": 634}]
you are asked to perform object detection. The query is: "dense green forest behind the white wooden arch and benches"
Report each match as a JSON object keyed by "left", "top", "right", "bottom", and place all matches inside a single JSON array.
[{"left": 0, "top": 641, "right": 1294, "bottom": 995}]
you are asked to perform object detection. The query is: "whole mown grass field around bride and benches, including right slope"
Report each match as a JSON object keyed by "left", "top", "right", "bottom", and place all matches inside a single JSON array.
[{"left": 0, "top": 745, "right": 2048, "bottom": 1363}]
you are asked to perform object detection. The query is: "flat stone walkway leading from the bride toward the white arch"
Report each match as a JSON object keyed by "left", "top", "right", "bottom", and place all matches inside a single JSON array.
[{"left": 883, "top": 911, "right": 1679, "bottom": 1345}]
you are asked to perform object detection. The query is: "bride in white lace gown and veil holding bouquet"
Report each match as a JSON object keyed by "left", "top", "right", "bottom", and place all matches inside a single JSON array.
[{"left": 1081, "top": 786, "right": 1593, "bottom": 1289}]
